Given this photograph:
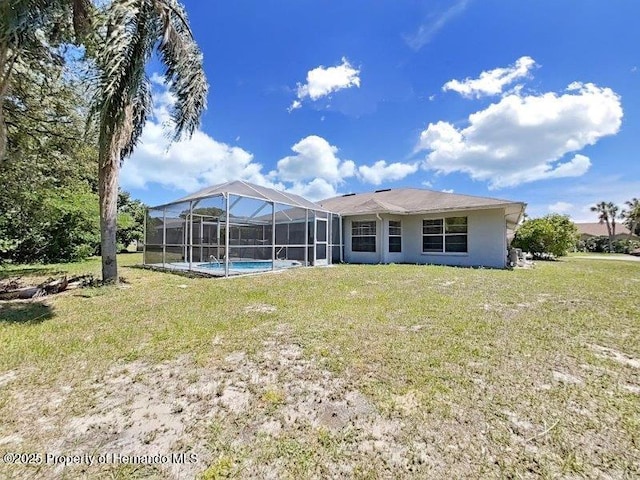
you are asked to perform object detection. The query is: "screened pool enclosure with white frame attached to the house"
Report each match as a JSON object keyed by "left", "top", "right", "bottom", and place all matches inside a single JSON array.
[{"left": 144, "top": 181, "right": 342, "bottom": 276}]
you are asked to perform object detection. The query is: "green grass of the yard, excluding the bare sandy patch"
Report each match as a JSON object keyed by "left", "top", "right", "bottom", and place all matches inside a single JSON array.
[{"left": 0, "top": 254, "right": 640, "bottom": 478}]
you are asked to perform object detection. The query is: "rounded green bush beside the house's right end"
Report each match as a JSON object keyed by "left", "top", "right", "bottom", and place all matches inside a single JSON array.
[{"left": 512, "top": 213, "right": 578, "bottom": 257}]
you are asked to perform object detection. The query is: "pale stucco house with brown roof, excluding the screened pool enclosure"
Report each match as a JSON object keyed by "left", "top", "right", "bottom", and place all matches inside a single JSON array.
[{"left": 318, "top": 188, "right": 526, "bottom": 268}]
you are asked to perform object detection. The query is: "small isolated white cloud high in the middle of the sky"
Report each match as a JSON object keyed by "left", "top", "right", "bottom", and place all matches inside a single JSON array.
[{"left": 289, "top": 57, "right": 360, "bottom": 112}]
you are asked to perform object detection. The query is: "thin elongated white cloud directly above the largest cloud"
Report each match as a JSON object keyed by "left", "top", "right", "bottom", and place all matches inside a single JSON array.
[{"left": 442, "top": 57, "right": 536, "bottom": 98}]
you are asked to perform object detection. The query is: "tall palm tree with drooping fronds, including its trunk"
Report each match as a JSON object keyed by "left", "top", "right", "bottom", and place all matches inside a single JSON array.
[{"left": 93, "top": 0, "right": 208, "bottom": 283}]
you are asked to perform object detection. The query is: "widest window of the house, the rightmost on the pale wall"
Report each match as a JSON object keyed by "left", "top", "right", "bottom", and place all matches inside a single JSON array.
[{"left": 422, "top": 217, "right": 467, "bottom": 253}]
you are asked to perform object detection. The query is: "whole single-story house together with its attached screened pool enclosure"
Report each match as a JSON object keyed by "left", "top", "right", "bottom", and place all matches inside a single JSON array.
[{"left": 143, "top": 181, "right": 525, "bottom": 276}]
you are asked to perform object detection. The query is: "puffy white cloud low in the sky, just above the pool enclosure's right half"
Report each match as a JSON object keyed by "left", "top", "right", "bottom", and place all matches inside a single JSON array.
[{"left": 272, "top": 135, "right": 356, "bottom": 185}]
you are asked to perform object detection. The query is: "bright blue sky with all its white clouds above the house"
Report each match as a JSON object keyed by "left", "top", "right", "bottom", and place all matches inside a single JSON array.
[{"left": 120, "top": 0, "right": 640, "bottom": 221}]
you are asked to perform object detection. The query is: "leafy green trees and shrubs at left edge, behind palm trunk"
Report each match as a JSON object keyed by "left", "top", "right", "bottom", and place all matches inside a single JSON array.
[{"left": 0, "top": 41, "right": 100, "bottom": 262}]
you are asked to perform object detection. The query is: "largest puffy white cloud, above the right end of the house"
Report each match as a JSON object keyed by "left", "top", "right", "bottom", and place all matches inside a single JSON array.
[{"left": 416, "top": 82, "right": 623, "bottom": 189}]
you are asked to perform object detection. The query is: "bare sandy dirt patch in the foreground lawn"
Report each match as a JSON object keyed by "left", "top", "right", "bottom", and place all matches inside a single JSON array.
[{"left": 0, "top": 332, "right": 440, "bottom": 479}]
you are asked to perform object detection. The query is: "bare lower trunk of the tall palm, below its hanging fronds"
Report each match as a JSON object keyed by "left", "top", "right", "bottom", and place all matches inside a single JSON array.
[{"left": 98, "top": 142, "right": 120, "bottom": 284}]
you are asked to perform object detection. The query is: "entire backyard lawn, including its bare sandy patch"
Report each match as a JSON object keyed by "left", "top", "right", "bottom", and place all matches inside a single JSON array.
[{"left": 0, "top": 254, "right": 640, "bottom": 479}]
